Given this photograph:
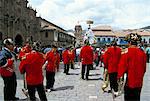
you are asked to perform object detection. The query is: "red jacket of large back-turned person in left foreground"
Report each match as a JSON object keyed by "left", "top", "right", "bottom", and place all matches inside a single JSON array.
[{"left": 19, "top": 51, "right": 44, "bottom": 85}]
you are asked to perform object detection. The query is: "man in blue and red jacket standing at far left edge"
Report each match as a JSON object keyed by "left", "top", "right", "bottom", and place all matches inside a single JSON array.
[{"left": 0, "top": 38, "right": 19, "bottom": 101}]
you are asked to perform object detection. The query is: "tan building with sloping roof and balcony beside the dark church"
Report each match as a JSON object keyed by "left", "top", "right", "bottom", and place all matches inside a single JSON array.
[{"left": 39, "top": 17, "right": 75, "bottom": 47}]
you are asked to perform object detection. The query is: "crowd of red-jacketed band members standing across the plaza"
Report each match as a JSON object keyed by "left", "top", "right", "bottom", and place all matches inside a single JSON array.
[{"left": 0, "top": 33, "right": 150, "bottom": 101}]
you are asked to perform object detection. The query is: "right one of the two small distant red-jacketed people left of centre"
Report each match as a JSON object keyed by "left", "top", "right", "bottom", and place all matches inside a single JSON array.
[{"left": 68, "top": 47, "right": 75, "bottom": 69}]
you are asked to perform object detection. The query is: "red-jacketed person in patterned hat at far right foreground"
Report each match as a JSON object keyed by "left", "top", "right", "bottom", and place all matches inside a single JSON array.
[{"left": 118, "top": 33, "right": 146, "bottom": 101}]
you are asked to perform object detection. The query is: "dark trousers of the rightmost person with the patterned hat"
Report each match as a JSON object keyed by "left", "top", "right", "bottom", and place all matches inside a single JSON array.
[{"left": 124, "top": 86, "right": 142, "bottom": 101}]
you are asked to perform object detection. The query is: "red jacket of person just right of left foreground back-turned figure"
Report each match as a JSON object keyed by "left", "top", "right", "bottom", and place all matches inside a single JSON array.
[{"left": 45, "top": 50, "right": 59, "bottom": 72}]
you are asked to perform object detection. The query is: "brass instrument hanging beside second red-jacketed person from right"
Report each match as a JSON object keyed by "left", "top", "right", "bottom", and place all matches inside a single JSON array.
[{"left": 101, "top": 69, "right": 109, "bottom": 92}]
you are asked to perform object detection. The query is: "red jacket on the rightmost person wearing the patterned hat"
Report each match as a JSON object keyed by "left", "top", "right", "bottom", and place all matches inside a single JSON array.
[{"left": 118, "top": 47, "right": 146, "bottom": 88}]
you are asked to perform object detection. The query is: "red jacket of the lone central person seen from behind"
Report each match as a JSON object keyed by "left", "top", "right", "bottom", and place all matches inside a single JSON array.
[{"left": 80, "top": 46, "right": 93, "bottom": 64}]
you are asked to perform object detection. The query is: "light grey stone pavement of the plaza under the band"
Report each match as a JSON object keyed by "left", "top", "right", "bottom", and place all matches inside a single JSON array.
[{"left": 0, "top": 63, "right": 150, "bottom": 101}]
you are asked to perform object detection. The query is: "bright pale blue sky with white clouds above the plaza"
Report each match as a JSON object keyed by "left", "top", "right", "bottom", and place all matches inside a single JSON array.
[{"left": 28, "top": 0, "right": 150, "bottom": 30}]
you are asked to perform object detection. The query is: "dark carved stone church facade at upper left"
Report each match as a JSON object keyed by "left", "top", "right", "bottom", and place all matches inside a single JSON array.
[{"left": 0, "top": 0, "right": 40, "bottom": 45}]
